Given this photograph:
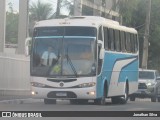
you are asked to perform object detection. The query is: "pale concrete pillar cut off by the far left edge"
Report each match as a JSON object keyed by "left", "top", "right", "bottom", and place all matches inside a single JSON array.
[{"left": 0, "top": 0, "right": 6, "bottom": 52}]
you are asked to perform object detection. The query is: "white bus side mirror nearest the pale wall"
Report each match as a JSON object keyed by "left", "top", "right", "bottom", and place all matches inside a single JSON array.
[{"left": 25, "top": 37, "right": 32, "bottom": 56}]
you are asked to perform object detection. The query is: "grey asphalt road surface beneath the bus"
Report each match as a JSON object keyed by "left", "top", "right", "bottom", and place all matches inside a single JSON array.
[{"left": 0, "top": 98, "right": 160, "bottom": 111}]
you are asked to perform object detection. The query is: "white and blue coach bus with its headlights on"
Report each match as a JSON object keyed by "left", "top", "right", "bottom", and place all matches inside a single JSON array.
[{"left": 30, "top": 16, "right": 139, "bottom": 105}]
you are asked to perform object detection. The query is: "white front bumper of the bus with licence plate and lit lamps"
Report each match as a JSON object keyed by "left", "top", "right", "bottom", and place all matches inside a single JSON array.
[{"left": 31, "top": 87, "right": 96, "bottom": 99}]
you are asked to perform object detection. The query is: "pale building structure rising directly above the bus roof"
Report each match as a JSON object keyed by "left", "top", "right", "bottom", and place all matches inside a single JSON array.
[{"left": 74, "top": 0, "right": 119, "bottom": 21}]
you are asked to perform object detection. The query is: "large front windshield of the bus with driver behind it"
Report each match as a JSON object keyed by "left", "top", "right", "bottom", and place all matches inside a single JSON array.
[{"left": 31, "top": 27, "right": 96, "bottom": 77}]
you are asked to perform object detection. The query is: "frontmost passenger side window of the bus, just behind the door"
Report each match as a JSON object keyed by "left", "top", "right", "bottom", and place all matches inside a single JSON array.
[{"left": 103, "top": 27, "right": 110, "bottom": 50}]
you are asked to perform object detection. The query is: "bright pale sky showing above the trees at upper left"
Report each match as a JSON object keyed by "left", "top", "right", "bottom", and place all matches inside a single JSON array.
[{"left": 6, "top": 0, "right": 57, "bottom": 12}]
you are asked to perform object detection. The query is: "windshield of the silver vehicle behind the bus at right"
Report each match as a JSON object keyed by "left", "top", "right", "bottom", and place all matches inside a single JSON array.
[{"left": 139, "top": 71, "right": 154, "bottom": 79}]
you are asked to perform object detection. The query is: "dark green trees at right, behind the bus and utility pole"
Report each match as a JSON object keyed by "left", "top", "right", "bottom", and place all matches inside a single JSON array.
[{"left": 118, "top": 0, "right": 160, "bottom": 70}]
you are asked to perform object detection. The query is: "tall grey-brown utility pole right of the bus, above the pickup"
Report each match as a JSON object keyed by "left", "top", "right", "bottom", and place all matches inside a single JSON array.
[{"left": 142, "top": 0, "right": 151, "bottom": 69}]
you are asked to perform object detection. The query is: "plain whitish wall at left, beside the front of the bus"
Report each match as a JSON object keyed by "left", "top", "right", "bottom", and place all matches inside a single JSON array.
[{"left": 0, "top": 53, "right": 30, "bottom": 96}]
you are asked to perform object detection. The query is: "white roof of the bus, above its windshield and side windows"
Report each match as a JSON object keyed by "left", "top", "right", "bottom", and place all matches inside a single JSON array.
[{"left": 35, "top": 16, "right": 137, "bottom": 34}]
